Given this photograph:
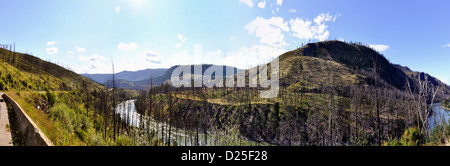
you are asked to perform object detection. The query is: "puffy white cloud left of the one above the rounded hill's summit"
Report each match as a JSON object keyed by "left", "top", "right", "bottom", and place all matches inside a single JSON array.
[{"left": 245, "top": 17, "right": 289, "bottom": 47}]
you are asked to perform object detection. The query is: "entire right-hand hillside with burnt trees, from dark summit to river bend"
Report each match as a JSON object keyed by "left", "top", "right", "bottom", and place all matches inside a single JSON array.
[{"left": 127, "top": 41, "right": 450, "bottom": 146}]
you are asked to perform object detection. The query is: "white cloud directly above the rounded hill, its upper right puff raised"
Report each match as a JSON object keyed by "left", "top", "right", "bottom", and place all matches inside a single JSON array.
[{"left": 289, "top": 13, "right": 335, "bottom": 41}]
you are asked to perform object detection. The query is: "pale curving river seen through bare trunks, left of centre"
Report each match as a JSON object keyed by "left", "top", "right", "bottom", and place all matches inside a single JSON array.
[{"left": 115, "top": 100, "right": 270, "bottom": 146}]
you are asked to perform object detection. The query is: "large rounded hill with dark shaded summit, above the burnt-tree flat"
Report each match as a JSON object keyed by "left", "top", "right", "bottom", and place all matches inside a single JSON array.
[{"left": 279, "top": 41, "right": 450, "bottom": 98}]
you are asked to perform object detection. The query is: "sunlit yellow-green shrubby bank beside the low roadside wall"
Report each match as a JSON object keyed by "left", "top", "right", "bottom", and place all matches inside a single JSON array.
[{"left": 6, "top": 91, "right": 153, "bottom": 146}]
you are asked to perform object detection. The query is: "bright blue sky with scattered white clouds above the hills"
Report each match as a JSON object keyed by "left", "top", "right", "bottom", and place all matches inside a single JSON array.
[{"left": 0, "top": 0, "right": 450, "bottom": 84}]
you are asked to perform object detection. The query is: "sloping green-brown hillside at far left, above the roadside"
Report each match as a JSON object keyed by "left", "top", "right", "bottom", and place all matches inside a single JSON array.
[{"left": 0, "top": 48, "right": 102, "bottom": 91}]
